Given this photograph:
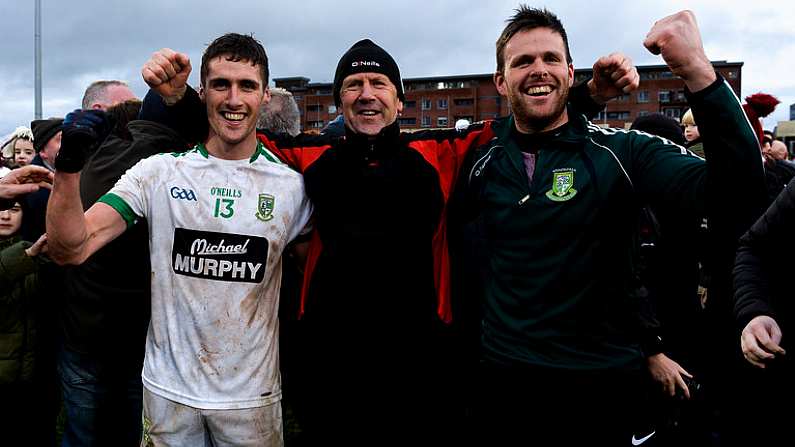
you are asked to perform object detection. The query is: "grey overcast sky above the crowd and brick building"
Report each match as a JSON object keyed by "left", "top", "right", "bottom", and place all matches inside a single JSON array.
[{"left": 0, "top": 0, "right": 795, "bottom": 136}]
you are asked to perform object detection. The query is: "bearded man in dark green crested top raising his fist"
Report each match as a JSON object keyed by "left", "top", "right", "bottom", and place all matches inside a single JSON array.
[{"left": 451, "top": 7, "right": 764, "bottom": 445}]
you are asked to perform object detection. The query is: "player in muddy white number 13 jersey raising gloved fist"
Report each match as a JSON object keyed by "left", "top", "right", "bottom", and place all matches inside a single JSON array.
[{"left": 42, "top": 34, "right": 311, "bottom": 446}]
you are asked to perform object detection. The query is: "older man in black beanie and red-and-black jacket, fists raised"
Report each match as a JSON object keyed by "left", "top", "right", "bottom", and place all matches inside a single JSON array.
[{"left": 142, "top": 32, "right": 637, "bottom": 445}]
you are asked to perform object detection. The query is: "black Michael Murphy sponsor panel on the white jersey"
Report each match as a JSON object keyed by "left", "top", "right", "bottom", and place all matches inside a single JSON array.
[{"left": 171, "top": 228, "right": 268, "bottom": 283}]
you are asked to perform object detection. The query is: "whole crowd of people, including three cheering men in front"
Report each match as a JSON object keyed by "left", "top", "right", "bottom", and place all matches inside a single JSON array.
[{"left": 0, "top": 6, "right": 795, "bottom": 446}]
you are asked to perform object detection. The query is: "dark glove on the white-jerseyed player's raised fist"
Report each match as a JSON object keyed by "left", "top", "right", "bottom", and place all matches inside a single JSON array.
[{"left": 55, "top": 109, "right": 114, "bottom": 174}]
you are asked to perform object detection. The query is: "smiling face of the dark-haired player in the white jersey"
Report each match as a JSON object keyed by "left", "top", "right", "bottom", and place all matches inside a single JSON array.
[{"left": 200, "top": 56, "right": 270, "bottom": 159}]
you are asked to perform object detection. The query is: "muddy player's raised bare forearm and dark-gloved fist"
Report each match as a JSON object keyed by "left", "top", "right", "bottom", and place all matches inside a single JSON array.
[{"left": 47, "top": 111, "right": 126, "bottom": 264}]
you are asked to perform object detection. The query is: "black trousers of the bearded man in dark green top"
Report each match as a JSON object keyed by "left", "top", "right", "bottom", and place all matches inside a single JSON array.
[{"left": 468, "top": 362, "right": 640, "bottom": 446}]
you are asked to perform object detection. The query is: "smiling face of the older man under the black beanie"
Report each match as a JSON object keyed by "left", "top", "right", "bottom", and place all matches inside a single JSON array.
[{"left": 340, "top": 73, "right": 403, "bottom": 136}]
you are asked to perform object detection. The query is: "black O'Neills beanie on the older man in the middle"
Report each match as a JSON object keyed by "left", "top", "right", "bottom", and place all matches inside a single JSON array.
[{"left": 334, "top": 39, "right": 406, "bottom": 107}]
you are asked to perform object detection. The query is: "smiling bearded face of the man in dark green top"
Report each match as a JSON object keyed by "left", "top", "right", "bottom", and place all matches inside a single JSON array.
[{"left": 494, "top": 28, "right": 574, "bottom": 133}]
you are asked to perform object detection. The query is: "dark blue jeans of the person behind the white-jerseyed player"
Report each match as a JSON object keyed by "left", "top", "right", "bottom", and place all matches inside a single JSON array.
[{"left": 58, "top": 346, "right": 143, "bottom": 447}]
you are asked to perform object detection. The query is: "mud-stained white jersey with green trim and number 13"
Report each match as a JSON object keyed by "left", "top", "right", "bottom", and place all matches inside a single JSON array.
[{"left": 100, "top": 144, "right": 311, "bottom": 409}]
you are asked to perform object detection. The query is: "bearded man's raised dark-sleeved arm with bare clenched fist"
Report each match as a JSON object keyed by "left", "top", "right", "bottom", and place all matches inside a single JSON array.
[{"left": 632, "top": 11, "right": 765, "bottom": 220}]
